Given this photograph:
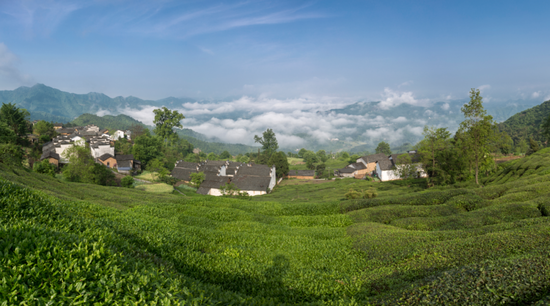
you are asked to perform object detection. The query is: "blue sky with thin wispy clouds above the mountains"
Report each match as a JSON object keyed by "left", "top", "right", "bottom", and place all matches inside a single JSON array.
[{"left": 0, "top": 0, "right": 550, "bottom": 103}]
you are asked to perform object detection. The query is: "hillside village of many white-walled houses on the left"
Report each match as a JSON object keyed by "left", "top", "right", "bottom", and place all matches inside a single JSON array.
[{"left": 40, "top": 124, "right": 141, "bottom": 173}]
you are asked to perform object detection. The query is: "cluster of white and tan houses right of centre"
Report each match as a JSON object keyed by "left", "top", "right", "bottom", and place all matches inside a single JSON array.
[{"left": 334, "top": 151, "right": 428, "bottom": 182}]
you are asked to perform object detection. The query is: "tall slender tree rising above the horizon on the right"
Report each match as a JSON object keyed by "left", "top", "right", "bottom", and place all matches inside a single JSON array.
[{"left": 459, "top": 88, "right": 495, "bottom": 184}]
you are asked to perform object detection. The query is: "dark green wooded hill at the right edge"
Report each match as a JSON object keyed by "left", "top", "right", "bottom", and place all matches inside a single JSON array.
[{"left": 499, "top": 100, "right": 550, "bottom": 144}]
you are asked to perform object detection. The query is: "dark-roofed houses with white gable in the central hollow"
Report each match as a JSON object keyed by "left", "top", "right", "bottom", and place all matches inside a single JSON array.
[{"left": 171, "top": 160, "right": 277, "bottom": 196}]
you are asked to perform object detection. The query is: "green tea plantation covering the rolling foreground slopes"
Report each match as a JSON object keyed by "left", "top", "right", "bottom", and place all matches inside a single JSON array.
[{"left": 0, "top": 149, "right": 550, "bottom": 305}]
